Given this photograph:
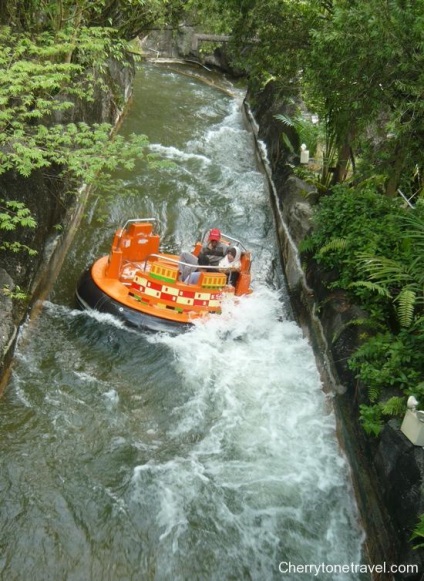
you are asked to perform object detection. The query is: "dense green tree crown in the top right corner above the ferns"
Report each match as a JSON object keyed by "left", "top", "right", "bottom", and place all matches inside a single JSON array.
[{"left": 305, "top": 0, "right": 424, "bottom": 196}]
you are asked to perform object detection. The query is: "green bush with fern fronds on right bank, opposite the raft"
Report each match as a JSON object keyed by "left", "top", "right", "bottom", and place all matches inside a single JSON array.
[{"left": 303, "top": 182, "right": 424, "bottom": 435}]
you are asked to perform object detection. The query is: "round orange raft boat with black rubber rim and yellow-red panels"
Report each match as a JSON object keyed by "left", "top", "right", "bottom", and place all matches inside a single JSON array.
[{"left": 76, "top": 218, "right": 252, "bottom": 333}]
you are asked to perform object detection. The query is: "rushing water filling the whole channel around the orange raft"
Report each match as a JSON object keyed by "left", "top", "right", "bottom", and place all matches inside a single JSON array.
[{"left": 0, "top": 66, "right": 368, "bottom": 581}]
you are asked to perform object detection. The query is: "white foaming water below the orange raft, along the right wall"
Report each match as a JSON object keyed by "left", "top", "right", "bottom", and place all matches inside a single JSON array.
[{"left": 138, "top": 289, "right": 361, "bottom": 579}]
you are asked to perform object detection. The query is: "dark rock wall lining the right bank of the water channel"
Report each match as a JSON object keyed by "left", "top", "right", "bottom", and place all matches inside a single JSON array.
[{"left": 246, "top": 84, "right": 424, "bottom": 581}]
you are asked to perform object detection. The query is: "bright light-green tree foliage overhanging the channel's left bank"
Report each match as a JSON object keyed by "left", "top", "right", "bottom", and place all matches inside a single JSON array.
[{"left": 0, "top": 10, "right": 166, "bottom": 278}]
